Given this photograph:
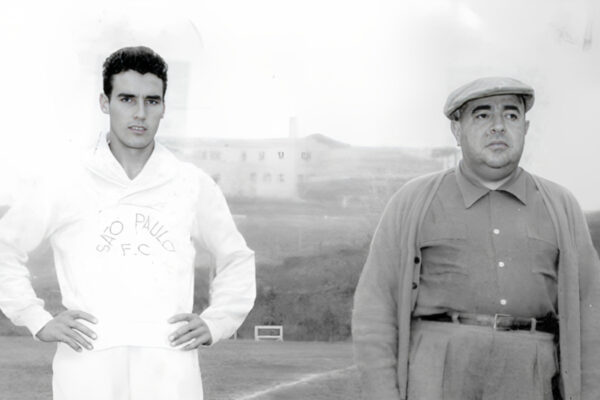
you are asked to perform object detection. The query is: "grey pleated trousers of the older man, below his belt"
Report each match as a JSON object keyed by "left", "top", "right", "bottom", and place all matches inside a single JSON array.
[{"left": 408, "top": 320, "right": 559, "bottom": 400}]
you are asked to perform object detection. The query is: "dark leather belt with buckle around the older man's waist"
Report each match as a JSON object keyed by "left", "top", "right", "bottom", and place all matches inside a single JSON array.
[{"left": 419, "top": 312, "right": 558, "bottom": 334}]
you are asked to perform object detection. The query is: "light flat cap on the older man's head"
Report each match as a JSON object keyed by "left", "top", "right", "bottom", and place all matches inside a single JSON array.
[{"left": 444, "top": 77, "right": 535, "bottom": 119}]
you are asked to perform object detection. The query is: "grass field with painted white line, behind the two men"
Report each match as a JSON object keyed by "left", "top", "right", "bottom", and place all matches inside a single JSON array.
[{"left": 0, "top": 336, "right": 358, "bottom": 400}]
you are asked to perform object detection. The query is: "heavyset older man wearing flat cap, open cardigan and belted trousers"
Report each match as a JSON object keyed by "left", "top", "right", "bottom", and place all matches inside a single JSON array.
[{"left": 353, "top": 78, "right": 600, "bottom": 400}]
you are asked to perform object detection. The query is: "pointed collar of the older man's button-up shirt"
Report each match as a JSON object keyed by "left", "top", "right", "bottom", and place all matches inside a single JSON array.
[{"left": 456, "top": 162, "right": 527, "bottom": 208}]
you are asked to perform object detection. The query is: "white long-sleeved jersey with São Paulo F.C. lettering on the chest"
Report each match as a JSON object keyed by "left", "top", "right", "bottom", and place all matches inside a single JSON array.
[{"left": 0, "top": 140, "right": 256, "bottom": 350}]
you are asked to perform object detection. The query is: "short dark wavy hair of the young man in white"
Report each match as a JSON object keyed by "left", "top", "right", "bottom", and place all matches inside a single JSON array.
[{"left": 102, "top": 46, "right": 168, "bottom": 99}]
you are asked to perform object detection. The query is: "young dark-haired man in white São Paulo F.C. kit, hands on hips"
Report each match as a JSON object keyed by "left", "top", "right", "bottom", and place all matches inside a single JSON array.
[{"left": 0, "top": 47, "right": 256, "bottom": 400}]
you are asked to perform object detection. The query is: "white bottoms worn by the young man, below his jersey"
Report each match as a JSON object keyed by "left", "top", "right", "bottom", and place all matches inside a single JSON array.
[{"left": 52, "top": 343, "right": 203, "bottom": 400}]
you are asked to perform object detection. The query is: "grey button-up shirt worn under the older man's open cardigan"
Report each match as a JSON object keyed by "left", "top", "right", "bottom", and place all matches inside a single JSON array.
[{"left": 413, "top": 165, "right": 558, "bottom": 318}]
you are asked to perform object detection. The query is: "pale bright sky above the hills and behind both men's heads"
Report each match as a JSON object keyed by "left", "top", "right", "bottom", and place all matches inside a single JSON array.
[{"left": 0, "top": 0, "right": 600, "bottom": 210}]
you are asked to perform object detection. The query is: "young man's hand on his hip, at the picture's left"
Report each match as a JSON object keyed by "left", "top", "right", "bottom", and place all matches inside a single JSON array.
[{"left": 35, "top": 310, "right": 98, "bottom": 351}]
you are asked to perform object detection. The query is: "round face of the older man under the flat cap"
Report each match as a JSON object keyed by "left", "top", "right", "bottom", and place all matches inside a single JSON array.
[{"left": 452, "top": 95, "right": 529, "bottom": 182}]
